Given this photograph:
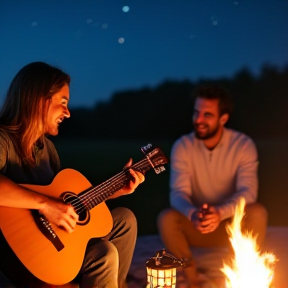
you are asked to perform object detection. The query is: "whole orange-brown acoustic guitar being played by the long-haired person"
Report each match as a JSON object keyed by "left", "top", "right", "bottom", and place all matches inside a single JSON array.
[{"left": 0, "top": 144, "right": 168, "bottom": 285}]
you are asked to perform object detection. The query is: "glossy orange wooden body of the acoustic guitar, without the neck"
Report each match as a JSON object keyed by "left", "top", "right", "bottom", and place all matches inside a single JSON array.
[{"left": 0, "top": 169, "right": 113, "bottom": 285}]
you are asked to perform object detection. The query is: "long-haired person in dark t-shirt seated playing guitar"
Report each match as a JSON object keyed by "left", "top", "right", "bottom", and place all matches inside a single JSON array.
[{"left": 0, "top": 62, "right": 144, "bottom": 288}]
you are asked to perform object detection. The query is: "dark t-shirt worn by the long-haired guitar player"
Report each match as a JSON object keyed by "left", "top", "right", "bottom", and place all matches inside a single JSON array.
[{"left": 0, "top": 131, "right": 60, "bottom": 185}]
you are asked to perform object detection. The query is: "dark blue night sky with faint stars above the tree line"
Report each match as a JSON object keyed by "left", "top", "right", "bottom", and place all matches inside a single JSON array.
[{"left": 0, "top": 0, "right": 288, "bottom": 107}]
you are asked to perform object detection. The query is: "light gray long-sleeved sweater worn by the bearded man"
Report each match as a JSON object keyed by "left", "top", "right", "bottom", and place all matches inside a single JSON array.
[{"left": 170, "top": 128, "right": 258, "bottom": 220}]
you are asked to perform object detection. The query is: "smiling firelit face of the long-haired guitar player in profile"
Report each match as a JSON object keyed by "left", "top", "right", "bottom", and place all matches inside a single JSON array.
[{"left": 46, "top": 84, "right": 70, "bottom": 136}]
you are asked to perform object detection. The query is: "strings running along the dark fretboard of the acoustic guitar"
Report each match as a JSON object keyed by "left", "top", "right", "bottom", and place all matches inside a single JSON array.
[{"left": 71, "top": 159, "right": 151, "bottom": 213}]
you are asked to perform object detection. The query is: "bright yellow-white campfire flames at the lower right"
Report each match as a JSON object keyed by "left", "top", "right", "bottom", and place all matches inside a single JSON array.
[{"left": 221, "top": 198, "right": 276, "bottom": 288}]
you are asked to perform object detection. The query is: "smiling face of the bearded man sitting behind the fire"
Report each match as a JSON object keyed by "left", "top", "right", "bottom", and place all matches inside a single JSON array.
[{"left": 193, "top": 98, "right": 227, "bottom": 140}]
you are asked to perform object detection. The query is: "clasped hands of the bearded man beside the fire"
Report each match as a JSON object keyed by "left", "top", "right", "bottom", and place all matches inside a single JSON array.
[{"left": 192, "top": 203, "right": 221, "bottom": 234}]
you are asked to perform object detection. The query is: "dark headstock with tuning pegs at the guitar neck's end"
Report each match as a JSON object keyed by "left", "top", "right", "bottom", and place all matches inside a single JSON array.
[{"left": 141, "top": 144, "right": 168, "bottom": 174}]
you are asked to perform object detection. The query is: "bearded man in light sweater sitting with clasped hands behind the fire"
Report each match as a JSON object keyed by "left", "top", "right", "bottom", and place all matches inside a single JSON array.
[{"left": 157, "top": 85, "right": 267, "bottom": 288}]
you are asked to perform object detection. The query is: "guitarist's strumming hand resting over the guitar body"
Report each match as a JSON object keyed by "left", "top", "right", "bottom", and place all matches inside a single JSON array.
[{"left": 39, "top": 198, "right": 79, "bottom": 233}]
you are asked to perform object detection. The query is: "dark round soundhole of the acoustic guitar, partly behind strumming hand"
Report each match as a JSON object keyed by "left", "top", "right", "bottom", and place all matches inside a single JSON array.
[{"left": 62, "top": 192, "right": 90, "bottom": 225}]
